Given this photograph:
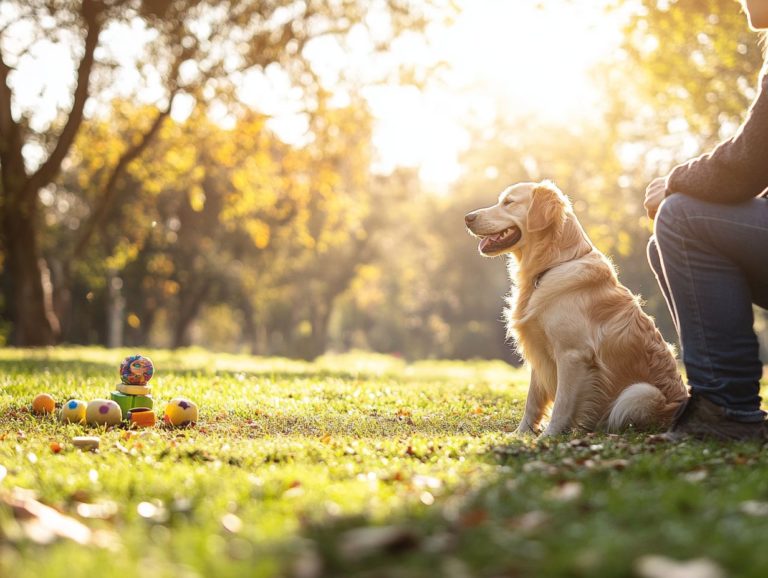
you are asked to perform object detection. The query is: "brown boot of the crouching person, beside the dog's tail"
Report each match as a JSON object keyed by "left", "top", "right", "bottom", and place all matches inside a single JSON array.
[{"left": 661, "top": 393, "right": 766, "bottom": 442}]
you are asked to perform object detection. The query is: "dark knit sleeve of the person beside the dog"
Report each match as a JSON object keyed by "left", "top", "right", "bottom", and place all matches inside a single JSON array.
[{"left": 666, "top": 74, "right": 768, "bottom": 203}]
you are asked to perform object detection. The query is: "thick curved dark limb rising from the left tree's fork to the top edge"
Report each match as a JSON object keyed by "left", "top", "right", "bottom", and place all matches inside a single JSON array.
[{"left": 24, "top": 0, "right": 104, "bottom": 195}]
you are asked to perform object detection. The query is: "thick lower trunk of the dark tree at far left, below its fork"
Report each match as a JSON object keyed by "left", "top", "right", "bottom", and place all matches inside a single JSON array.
[{"left": 3, "top": 195, "right": 59, "bottom": 347}]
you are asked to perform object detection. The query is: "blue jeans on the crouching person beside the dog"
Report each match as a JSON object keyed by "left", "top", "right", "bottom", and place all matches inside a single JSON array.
[{"left": 648, "top": 193, "right": 768, "bottom": 421}]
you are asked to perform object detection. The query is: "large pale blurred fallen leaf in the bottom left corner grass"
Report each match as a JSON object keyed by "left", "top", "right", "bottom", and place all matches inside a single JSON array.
[{"left": 0, "top": 489, "right": 118, "bottom": 548}]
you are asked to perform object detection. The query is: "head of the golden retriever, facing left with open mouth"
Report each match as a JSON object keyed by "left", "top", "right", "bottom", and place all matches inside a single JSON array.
[{"left": 464, "top": 181, "right": 570, "bottom": 257}]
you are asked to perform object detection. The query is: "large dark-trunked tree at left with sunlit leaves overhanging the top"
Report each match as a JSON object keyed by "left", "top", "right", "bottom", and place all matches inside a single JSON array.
[{"left": 0, "top": 0, "right": 448, "bottom": 345}]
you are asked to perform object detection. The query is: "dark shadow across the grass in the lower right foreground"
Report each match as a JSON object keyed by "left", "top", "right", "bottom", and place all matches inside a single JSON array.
[{"left": 288, "top": 436, "right": 768, "bottom": 578}]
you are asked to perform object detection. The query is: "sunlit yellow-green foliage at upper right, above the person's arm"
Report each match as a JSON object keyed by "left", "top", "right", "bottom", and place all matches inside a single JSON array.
[{"left": 625, "top": 0, "right": 763, "bottom": 145}]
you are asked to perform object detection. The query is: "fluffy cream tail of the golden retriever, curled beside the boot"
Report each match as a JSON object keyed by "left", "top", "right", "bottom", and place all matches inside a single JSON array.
[{"left": 606, "top": 382, "right": 679, "bottom": 432}]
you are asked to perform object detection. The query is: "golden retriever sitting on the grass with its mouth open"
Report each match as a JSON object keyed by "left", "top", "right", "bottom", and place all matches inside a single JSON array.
[{"left": 465, "top": 181, "right": 688, "bottom": 436}]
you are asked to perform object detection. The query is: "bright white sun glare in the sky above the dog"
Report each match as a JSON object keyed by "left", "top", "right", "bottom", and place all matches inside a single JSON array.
[{"left": 360, "top": 0, "right": 622, "bottom": 190}]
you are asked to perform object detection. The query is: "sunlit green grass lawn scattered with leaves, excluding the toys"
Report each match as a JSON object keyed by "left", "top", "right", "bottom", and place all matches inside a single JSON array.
[{"left": 0, "top": 348, "right": 768, "bottom": 578}]
